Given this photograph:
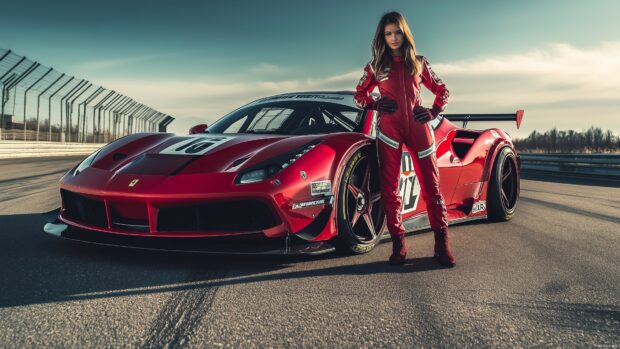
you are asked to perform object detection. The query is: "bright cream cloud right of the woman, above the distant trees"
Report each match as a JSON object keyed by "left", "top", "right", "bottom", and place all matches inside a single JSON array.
[{"left": 424, "top": 42, "right": 620, "bottom": 137}]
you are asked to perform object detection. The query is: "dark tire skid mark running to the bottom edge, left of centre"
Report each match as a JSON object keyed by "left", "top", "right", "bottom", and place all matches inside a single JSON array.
[{"left": 142, "top": 270, "right": 226, "bottom": 348}]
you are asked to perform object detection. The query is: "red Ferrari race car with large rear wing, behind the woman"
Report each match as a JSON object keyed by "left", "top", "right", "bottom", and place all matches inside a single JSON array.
[{"left": 44, "top": 92, "right": 523, "bottom": 254}]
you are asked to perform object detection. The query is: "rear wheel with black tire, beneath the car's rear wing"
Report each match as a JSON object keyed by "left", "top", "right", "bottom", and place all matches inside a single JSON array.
[{"left": 487, "top": 147, "right": 520, "bottom": 222}]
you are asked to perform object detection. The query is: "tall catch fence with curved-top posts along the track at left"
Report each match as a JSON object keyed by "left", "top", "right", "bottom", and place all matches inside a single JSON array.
[{"left": 0, "top": 48, "right": 174, "bottom": 143}]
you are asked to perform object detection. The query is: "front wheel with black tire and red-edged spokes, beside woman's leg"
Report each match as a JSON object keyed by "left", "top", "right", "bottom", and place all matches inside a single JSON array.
[{"left": 335, "top": 148, "right": 385, "bottom": 254}]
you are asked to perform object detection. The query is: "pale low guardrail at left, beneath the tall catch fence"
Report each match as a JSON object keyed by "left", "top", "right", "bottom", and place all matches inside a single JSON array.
[{"left": 0, "top": 141, "right": 105, "bottom": 159}]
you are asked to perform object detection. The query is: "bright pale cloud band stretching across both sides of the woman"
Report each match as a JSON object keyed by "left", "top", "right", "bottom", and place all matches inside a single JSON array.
[{"left": 97, "top": 42, "right": 620, "bottom": 136}]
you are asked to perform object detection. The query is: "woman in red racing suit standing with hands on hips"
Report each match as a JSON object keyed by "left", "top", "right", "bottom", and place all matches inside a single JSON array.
[{"left": 354, "top": 12, "right": 455, "bottom": 267}]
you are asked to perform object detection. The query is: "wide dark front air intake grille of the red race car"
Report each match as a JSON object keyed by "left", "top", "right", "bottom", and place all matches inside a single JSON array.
[{"left": 58, "top": 189, "right": 289, "bottom": 238}]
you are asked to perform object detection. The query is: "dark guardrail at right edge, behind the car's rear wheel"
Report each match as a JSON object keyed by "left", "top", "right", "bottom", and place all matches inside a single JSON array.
[{"left": 520, "top": 153, "right": 620, "bottom": 179}]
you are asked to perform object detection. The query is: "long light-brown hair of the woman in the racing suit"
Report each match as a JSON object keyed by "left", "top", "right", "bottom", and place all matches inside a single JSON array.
[{"left": 371, "top": 11, "right": 422, "bottom": 76}]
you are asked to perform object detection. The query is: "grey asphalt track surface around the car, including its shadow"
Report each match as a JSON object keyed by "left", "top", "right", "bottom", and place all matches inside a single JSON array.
[{"left": 0, "top": 158, "right": 620, "bottom": 348}]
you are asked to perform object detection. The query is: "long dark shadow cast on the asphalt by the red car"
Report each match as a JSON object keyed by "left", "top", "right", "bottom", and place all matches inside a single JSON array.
[{"left": 0, "top": 214, "right": 450, "bottom": 308}]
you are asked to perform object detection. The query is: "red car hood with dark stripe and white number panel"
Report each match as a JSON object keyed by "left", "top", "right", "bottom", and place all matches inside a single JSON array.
[{"left": 93, "top": 134, "right": 320, "bottom": 176}]
